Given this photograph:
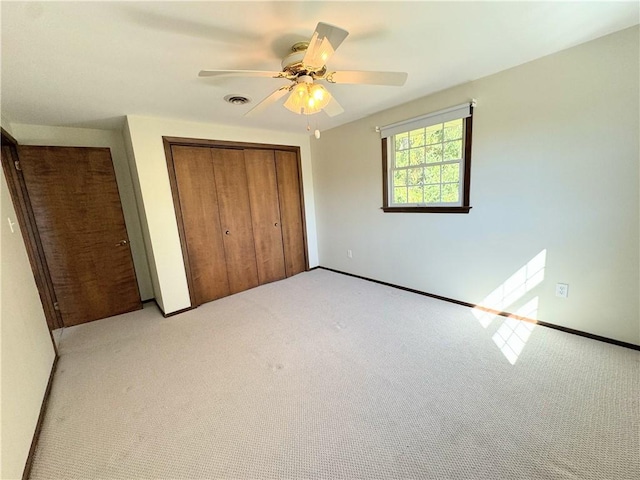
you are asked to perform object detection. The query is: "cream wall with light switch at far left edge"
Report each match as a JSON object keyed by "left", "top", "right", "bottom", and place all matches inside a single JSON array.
[{"left": 0, "top": 162, "right": 55, "bottom": 479}]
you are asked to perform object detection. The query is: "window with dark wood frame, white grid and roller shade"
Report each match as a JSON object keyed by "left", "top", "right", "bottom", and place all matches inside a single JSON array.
[{"left": 381, "top": 103, "right": 474, "bottom": 213}]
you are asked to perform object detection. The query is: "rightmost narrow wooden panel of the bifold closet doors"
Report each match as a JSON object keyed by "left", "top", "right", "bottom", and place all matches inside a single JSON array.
[{"left": 275, "top": 150, "right": 307, "bottom": 277}]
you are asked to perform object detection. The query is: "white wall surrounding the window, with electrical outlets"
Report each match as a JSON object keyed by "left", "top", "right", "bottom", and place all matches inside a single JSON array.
[{"left": 311, "top": 27, "right": 640, "bottom": 344}]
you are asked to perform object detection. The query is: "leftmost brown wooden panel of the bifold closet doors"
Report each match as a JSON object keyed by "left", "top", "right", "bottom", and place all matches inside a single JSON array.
[{"left": 171, "top": 145, "right": 230, "bottom": 307}]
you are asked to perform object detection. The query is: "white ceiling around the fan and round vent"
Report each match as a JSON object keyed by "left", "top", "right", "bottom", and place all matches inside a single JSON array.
[{"left": 1, "top": 1, "right": 639, "bottom": 132}]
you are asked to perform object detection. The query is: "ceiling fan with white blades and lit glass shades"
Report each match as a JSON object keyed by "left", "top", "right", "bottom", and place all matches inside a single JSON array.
[{"left": 199, "top": 22, "right": 407, "bottom": 117}]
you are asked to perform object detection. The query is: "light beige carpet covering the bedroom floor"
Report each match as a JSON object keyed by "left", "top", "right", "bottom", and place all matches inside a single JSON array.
[{"left": 31, "top": 270, "right": 640, "bottom": 480}]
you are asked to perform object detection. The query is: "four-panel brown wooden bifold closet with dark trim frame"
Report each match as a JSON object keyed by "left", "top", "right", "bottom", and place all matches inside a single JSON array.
[{"left": 164, "top": 137, "right": 307, "bottom": 307}]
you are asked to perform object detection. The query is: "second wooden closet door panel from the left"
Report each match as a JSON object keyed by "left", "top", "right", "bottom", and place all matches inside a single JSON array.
[{"left": 211, "top": 148, "right": 259, "bottom": 293}]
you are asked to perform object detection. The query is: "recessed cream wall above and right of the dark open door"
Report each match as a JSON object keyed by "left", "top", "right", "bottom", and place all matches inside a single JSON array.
[{"left": 11, "top": 123, "right": 153, "bottom": 300}]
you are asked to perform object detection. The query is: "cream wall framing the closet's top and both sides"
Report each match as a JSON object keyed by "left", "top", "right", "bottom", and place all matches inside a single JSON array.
[{"left": 125, "top": 115, "right": 318, "bottom": 313}]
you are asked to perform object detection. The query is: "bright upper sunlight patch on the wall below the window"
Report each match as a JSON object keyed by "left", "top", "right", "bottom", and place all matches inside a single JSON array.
[{"left": 473, "top": 248, "right": 547, "bottom": 328}]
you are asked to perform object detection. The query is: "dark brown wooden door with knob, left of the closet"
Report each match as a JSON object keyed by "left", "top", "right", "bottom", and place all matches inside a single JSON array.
[{"left": 18, "top": 146, "right": 142, "bottom": 327}]
